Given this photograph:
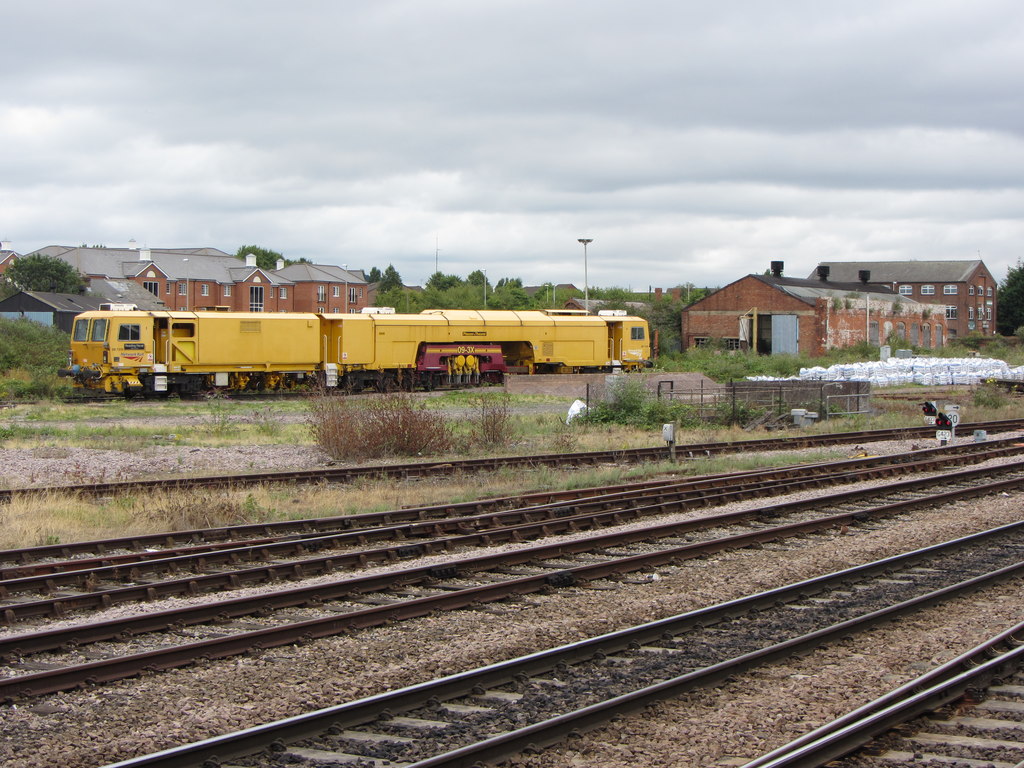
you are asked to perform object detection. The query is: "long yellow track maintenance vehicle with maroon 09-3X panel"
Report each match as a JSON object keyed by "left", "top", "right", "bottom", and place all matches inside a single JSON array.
[{"left": 60, "top": 309, "right": 650, "bottom": 395}]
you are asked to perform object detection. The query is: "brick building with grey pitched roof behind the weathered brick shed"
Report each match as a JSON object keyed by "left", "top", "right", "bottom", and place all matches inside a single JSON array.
[{"left": 811, "top": 259, "right": 998, "bottom": 339}]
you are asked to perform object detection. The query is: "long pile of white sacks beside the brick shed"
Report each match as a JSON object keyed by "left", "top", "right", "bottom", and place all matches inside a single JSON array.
[{"left": 800, "top": 357, "right": 1024, "bottom": 387}]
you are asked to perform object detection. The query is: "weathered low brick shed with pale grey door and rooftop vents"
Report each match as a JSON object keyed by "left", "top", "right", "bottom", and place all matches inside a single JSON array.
[{"left": 682, "top": 261, "right": 946, "bottom": 355}]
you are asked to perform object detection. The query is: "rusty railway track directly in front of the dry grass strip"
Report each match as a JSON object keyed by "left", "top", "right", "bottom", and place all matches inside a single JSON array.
[{"left": 0, "top": 438, "right": 1024, "bottom": 581}]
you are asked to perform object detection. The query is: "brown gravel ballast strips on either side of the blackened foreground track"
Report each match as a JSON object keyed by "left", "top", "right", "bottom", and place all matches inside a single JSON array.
[{"left": 0, "top": 436, "right": 1024, "bottom": 768}]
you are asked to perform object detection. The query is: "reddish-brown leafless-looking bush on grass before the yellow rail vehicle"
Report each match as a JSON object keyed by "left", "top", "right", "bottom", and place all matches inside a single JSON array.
[{"left": 307, "top": 390, "right": 452, "bottom": 460}]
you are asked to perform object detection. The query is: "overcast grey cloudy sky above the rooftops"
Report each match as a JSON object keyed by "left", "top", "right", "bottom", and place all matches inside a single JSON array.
[{"left": 0, "top": 0, "right": 1024, "bottom": 290}]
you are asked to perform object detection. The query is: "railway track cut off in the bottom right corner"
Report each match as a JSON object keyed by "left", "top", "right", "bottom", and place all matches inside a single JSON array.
[{"left": 743, "top": 624, "right": 1024, "bottom": 768}]
